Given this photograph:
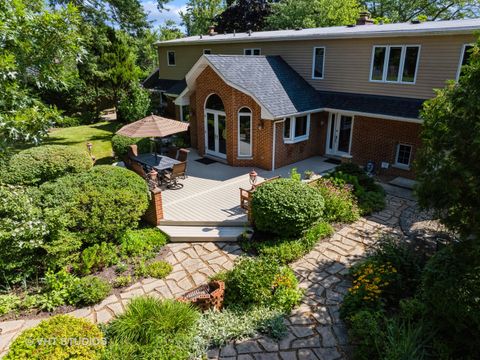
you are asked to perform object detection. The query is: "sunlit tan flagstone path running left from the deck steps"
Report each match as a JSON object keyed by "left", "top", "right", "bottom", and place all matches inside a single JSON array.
[{"left": 0, "top": 243, "right": 242, "bottom": 358}]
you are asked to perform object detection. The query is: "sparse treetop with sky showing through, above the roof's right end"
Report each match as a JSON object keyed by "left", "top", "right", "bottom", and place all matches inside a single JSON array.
[{"left": 362, "top": 0, "right": 480, "bottom": 22}]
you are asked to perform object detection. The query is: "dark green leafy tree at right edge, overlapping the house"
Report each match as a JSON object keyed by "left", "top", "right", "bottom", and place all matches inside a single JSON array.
[{"left": 417, "top": 41, "right": 480, "bottom": 236}]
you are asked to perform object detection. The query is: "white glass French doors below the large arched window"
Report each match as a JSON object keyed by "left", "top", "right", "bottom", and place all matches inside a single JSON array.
[{"left": 205, "top": 110, "right": 227, "bottom": 159}]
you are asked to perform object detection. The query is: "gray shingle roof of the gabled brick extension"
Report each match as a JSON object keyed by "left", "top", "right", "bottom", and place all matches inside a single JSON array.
[{"left": 205, "top": 55, "right": 321, "bottom": 118}]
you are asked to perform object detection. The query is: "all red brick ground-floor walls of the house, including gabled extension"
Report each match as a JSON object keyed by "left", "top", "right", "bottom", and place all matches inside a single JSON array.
[{"left": 184, "top": 67, "right": 421, "bottom": 178}]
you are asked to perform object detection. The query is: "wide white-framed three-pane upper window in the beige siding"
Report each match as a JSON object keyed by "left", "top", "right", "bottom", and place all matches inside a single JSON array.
[{"left": 370, "top": 45, "right": 420, "bottom": 84}]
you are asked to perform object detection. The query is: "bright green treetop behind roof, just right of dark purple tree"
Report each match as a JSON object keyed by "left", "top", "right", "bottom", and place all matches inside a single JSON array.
[{"left": 267, "top": 0, "right": 359, "bottom": 29}]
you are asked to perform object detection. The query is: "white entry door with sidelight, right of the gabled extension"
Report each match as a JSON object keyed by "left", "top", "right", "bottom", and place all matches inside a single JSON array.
[{"left": 326, "top": 113, "right": 353, "bottom": 156}]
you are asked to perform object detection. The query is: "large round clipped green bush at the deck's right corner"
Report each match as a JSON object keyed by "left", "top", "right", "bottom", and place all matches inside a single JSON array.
[{"left": 252, "top": 179, "right": 324, "bottom": 237}]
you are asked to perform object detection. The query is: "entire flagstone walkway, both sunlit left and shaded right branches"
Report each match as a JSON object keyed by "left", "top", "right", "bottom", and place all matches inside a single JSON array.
[{"left": 0, "top": 196, "right": 416, "bottom": 360}]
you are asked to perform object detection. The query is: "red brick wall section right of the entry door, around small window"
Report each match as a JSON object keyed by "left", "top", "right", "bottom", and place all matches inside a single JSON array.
[{"left": 352, "top": 116, "right": 421, "bottom": 178}]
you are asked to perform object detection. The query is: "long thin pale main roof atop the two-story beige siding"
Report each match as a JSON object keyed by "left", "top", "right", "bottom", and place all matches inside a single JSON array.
[{"left": 157, "top": 19, "right": 480, "bottom": 46}]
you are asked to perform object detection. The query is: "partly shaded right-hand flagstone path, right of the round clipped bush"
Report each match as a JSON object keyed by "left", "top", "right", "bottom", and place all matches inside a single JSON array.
[{"left": 208, "top": 196, "right": 415, "bottom": 360}]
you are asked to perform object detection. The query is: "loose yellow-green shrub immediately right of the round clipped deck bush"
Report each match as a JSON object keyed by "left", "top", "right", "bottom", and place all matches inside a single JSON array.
[{"left": 315, "top": 178, "right": 360, "bottom": 223}]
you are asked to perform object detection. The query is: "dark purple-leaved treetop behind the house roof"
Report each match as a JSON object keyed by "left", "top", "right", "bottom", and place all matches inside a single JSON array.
[{"left": 215, "top": 0, "right": 275, "bottom": 33}]
